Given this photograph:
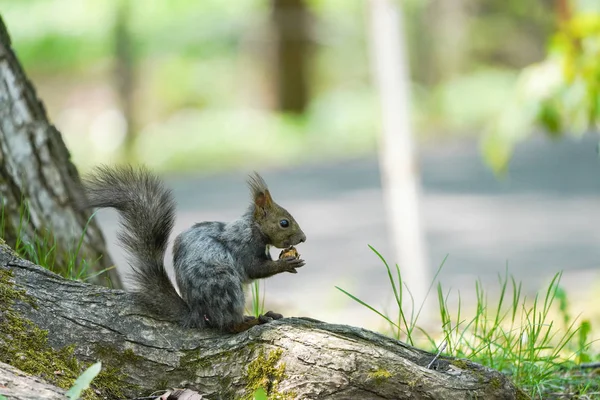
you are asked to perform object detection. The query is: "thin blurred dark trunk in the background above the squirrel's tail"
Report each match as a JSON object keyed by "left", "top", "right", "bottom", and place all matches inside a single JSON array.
[{"left": 114, "top": 0, "right": 136, "bottom": 160}]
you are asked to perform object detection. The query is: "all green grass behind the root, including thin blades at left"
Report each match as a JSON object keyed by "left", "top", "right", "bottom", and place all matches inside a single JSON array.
[{"left": 338, "top": 249, "right": 600, "bottom": 398}]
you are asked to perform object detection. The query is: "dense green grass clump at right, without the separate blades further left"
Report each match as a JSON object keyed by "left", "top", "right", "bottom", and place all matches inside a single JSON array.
[{"left": 438, "top": 274, "right": 589, "bottom": 398}]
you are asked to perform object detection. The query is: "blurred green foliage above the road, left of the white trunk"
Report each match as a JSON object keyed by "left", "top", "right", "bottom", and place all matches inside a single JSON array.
[{"left": 0, "top": 0, "right": 377, "bottom": 171}]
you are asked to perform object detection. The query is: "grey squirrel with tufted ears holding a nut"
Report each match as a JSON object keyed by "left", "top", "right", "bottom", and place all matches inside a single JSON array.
[{"left": 83, "top": 166, "right": 306, "bottom": 333}]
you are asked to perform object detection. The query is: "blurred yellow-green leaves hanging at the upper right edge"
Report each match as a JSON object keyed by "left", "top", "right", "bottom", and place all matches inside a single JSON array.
[{"left": 483, "top": 1, "right": 600, "bottom": 172}]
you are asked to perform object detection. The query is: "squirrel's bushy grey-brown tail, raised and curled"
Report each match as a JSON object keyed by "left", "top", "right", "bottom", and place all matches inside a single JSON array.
[{"left": 84, "top": 166, "right": 189, "bottom": 321}]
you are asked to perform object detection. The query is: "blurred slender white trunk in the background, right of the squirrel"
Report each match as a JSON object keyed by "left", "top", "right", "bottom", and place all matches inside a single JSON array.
[{"left": 369, "top": 0, "right": 430, "bottom": 318}]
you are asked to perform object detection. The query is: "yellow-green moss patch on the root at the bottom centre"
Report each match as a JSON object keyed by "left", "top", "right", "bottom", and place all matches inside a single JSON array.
[{"left": 243, "top": 349, "right": 296, "bottom": 400}]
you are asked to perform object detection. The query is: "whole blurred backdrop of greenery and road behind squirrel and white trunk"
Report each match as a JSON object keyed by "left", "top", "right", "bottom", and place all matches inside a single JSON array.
[{"left": 0, "top": 0, "right": 600, "bottom": 328}]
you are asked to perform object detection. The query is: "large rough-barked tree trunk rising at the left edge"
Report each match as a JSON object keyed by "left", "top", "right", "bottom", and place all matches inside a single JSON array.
[{"left": 0, "top": 17, "right": 121, "bottom": 288}]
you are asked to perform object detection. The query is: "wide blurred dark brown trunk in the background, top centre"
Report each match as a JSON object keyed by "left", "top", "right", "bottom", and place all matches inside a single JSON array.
[{"left": 272, "top": 0, "right": 310, "bottom": 114}]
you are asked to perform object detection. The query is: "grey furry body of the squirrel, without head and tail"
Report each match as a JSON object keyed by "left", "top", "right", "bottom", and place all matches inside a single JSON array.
[{"left": 173, "top": 209, "right": 271, "bottom": 329}]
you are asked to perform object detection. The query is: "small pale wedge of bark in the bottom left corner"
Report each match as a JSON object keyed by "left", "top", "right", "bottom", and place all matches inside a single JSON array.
[{"left": 0, "top": 363, "right": 65, "bottom": 400}]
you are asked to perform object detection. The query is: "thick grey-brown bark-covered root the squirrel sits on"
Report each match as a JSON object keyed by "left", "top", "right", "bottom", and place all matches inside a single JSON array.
[{"left": 0, "top": 245, "right": 527, "bottom": 400}]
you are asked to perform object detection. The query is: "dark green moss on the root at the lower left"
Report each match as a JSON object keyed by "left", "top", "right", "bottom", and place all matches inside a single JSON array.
[{"left": 0, "top": 268, "right": 135, "bottom": 400}]
